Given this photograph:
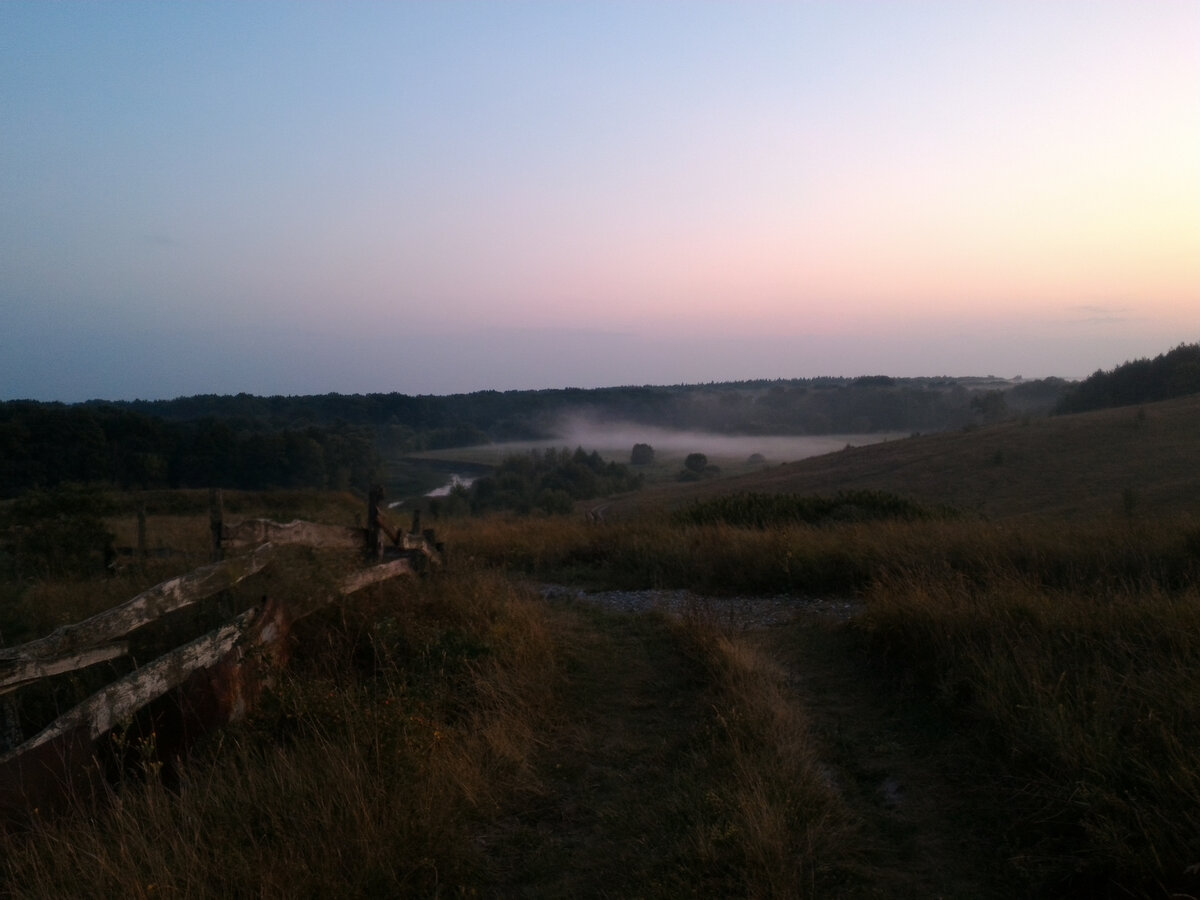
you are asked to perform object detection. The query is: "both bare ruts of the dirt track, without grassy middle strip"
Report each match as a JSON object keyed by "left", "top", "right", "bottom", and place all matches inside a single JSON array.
[{"left": 481, "top": 589, "right": 1021, "bottom": 900}]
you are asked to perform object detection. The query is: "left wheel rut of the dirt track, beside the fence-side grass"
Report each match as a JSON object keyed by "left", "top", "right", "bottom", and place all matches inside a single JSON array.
[{"left": 485, "top": 604, "right": 737, "bottom": 898}]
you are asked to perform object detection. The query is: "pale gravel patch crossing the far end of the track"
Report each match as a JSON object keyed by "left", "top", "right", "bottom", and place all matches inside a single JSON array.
[{"left": 536, "top": 584, "right": 862, "bottom": 630}]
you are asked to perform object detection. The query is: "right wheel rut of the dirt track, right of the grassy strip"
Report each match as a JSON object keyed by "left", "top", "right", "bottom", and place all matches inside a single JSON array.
[{"left": 750, "top": 613, "right": 1022, "bottom": 899}]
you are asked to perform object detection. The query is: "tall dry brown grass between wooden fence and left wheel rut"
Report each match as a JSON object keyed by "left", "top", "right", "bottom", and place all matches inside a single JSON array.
[{"left": 0, "top": 572, "right": 554, "bottom": 898}]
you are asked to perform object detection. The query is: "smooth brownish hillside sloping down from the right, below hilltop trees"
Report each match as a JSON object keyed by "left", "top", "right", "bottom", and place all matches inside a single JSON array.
[{"left": 614, "top": 396, "right": 1200, "bottom": 520}]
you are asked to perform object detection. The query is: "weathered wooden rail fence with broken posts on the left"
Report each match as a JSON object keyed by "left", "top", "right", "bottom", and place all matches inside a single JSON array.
[{"left": 0, "top": 488, "right": 443, "bottom": 821}]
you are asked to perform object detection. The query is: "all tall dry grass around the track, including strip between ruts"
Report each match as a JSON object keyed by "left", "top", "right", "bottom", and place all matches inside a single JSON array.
[{"left": 0, "top": 496, "right": 1200, "bottom": 896}]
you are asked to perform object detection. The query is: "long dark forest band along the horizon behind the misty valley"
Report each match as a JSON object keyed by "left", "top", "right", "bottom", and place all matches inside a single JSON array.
[{"left": 0, "top": 367, "right": 1113, "bottom": 497}]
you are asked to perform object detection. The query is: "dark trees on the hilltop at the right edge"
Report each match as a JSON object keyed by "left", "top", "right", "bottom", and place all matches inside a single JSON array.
[{"left": 1056, "top": 343, "right": 1200, "bottom": 413}]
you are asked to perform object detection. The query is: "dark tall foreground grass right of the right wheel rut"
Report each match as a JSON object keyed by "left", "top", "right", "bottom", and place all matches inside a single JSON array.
[{"left": 860, "top": 571, "right": 1200, "bottom": 895}]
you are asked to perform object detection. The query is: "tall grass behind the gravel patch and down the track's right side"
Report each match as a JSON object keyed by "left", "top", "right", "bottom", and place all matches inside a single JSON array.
[{"left": 446, "top": 508, "right": 1200, "bottom": 895}]
